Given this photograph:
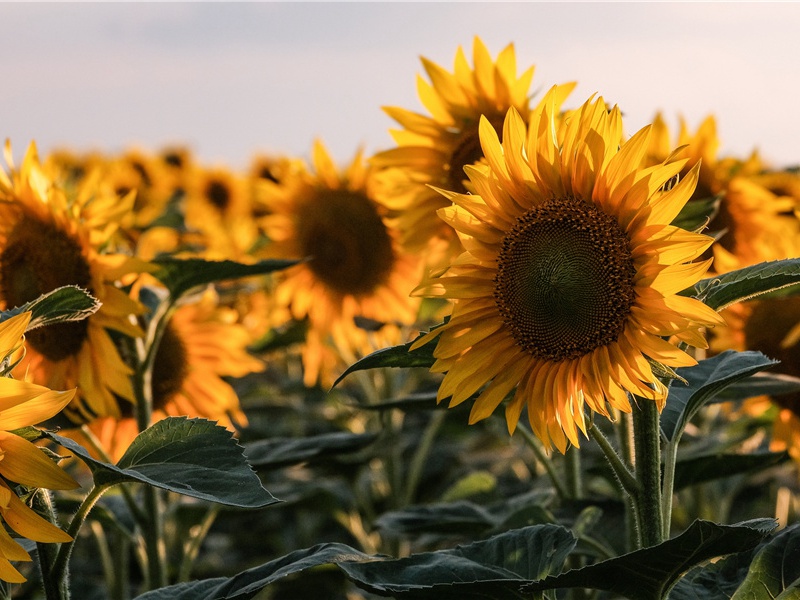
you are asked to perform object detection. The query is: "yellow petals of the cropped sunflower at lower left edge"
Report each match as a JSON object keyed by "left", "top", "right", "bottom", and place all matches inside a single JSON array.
[{"left": 0, "top": 312, "right": 78, "bottom": 583}]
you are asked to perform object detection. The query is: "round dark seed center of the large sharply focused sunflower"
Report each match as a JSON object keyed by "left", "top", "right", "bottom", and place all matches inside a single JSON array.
[{"left": 494, "top": 197, "right": 636, "bottom": 362}]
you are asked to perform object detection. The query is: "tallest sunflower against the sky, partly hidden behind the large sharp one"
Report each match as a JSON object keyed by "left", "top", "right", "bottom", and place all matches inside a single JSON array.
[{"left": 372, "top": 37, "right": 571, "bottom": 264}]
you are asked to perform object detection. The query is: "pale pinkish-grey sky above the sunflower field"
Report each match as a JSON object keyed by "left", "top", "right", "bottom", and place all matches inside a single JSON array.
[{"left": 0, "top": 2, "right": 800, "bottom": 168}]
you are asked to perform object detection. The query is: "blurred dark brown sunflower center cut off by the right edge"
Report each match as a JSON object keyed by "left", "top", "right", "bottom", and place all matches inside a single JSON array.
[{"left": 744, "top": 296, "right": 800, "bottom": 417}]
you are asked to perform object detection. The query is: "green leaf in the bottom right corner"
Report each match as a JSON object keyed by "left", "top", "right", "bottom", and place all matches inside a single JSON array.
[{"left": 731, "top": 525, "right": 800, "bottom": 600}]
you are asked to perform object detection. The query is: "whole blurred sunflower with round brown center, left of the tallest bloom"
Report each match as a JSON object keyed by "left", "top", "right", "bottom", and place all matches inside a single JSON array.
[{"left": 263, "top": 142, "right": 420, "bottom": 385}]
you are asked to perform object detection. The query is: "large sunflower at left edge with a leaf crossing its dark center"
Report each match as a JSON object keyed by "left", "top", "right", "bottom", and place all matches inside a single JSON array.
[{"left": 0, "top": 145, "right": 147, "bottom": 420}]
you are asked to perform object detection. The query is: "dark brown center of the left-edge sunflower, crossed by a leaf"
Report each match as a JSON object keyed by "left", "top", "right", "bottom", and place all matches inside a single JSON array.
[{"left": 0, "top": 216, "right": 92, "bottom": 361}]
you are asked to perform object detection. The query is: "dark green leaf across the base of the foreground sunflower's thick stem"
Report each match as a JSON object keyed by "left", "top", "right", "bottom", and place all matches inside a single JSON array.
[{"left": 523, "top": 519, "right": 777, "bottom": 600}]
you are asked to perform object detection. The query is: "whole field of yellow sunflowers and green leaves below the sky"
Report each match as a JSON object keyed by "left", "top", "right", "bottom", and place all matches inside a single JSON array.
[{"left": 0, "top": 37, "right": 800, "bottom": 600}]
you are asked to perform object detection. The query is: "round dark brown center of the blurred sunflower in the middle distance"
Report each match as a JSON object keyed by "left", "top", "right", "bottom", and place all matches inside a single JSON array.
[{"left": 297, "top": 189, "right": 395, "bottom": 296}]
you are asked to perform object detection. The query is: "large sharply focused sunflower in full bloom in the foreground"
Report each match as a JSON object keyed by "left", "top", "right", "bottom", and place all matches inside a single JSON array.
[{"left": 414, "top": 88, "right": 722, "bottom": 452}]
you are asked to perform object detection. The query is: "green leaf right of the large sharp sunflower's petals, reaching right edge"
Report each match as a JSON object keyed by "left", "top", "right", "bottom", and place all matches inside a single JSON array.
[{"left": 682, "top": 258, "right": 800, "bottom": 310}]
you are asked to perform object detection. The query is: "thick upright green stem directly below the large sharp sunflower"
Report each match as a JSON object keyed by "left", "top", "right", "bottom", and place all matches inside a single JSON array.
[{"left": 633, "top": 398, "right": 664, "bottom": 548}]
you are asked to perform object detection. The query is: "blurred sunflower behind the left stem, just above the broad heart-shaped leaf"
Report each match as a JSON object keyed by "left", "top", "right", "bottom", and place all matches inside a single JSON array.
[{"left": 79, "top": 289, "right": 264, "bottom": 461}]
